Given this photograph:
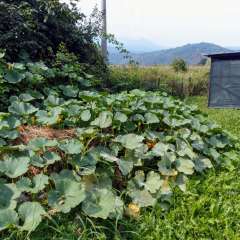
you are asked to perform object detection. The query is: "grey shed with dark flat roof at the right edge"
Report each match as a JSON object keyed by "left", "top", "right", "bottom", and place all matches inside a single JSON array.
[{"left": 207, "top": 52, "right": 240, "bottom": 108}]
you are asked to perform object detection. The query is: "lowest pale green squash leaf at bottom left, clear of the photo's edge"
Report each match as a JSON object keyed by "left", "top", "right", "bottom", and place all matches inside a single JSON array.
[{"left": 18, "top": 202, "right": 46, "bottom": 232}]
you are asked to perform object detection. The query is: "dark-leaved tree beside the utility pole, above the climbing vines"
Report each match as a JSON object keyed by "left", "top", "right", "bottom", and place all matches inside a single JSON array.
[{"left": 0, "top": 0, "right": 107, "bottom": 76}]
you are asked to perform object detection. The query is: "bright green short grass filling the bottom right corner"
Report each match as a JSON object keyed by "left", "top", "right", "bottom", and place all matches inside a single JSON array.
[{"left": 129, "top": 169, "right": 240, "bottom": 240}]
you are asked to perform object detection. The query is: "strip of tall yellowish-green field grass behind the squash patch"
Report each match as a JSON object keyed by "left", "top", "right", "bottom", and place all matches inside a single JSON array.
[{"left": 110, "top": 66, "right": 209, "bottom": 97}]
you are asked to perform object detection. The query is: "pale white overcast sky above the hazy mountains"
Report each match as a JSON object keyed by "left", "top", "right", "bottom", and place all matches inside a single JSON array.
[{"left": 66, "top": 0, "right": 240, "bottom": 47}]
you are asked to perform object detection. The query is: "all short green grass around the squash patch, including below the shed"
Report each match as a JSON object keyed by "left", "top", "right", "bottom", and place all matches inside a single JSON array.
[{"left": 0, "top": 97, "right": 240, "bottom": 240}]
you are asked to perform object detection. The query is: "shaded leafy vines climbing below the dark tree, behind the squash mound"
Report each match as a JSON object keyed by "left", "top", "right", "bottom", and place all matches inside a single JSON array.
[{"left": 0, "top": 50, "right": 102, "bottom": 111}]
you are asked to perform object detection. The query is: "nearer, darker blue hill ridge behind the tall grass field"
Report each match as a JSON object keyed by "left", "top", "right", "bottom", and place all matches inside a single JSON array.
[{"left": 109, "top": 42, "right": 232, "bottom": 65}]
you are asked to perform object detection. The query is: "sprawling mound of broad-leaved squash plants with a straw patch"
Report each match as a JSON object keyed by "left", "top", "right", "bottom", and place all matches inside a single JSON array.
[{"left": 0, "top": 79, "right": 237, "bottom": 232}]
